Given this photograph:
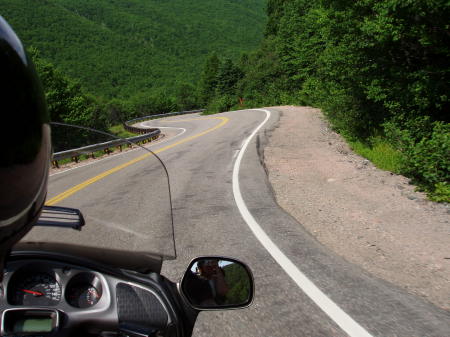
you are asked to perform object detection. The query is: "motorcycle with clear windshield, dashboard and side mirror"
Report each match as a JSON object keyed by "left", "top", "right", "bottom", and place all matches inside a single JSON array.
[{"left": 0, "top": 124, "right": 254, "bottom": 337}]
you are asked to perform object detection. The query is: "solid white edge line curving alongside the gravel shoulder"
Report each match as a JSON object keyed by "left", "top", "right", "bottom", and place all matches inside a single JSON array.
[{"left": 233, "top": 109, "right": 373, "bottom": 337}]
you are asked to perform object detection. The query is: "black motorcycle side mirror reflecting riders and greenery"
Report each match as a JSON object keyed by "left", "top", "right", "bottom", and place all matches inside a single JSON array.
[{"left": 181, "top": 256, "right": 254, "bottom": 310}]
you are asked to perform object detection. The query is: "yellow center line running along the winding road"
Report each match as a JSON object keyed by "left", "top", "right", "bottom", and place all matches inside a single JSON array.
[{"left": 46, "top": 117, "right": 229, "bottom": 206}]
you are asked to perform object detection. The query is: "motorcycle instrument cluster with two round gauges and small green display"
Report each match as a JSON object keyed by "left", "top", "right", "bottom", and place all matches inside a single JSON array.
[{"left": 0, "top": 259, "right": 115, "bottom": 336}]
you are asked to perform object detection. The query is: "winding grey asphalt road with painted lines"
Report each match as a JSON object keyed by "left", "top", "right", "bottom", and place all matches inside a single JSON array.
[{"left": 23, "top": 109, "right": 450, "bottom": 337}]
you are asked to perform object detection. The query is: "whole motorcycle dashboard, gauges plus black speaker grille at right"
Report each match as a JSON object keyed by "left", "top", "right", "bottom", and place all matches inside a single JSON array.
[{"left": 0, "top": 259, "right": 172, "bottom": 336}]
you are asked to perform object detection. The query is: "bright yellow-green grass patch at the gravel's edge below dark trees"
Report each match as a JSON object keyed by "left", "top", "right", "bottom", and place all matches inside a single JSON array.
[{"left": 347, "top": 138, "right": 403, "bottom": 174}]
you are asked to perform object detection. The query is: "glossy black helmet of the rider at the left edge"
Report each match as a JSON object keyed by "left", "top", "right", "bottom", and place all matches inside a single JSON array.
[{"left": 0, "top": 16, "right": 51, "bottom": 272}]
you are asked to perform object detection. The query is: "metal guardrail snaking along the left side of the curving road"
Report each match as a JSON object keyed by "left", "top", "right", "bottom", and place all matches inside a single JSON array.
[{"left": 52, "top": 109, "right": 205, "bottom": 167}]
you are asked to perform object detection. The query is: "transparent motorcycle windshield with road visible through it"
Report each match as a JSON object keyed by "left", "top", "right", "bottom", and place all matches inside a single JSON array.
[{"left": 16, "top": 123, "right": 176, "bottom": 271}]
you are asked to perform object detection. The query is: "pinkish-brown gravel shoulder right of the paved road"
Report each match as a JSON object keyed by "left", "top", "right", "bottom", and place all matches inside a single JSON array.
[{"left": 264, "top": 106, "right": 450, "bottom": 310}]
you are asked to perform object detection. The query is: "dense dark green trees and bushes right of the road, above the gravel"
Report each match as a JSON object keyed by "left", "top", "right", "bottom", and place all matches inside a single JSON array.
[{"left": 202, "top": 0, "right": 450, "bottom": 201}]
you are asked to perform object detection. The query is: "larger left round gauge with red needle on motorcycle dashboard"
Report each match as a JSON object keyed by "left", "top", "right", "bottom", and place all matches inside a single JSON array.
[{"left": 8, "top": 273, "right": 61, "bottom": 306}]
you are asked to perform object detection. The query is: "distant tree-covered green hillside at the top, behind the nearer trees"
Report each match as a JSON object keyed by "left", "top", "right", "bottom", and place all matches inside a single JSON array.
[{"left": 0, "top": 0, "right": 266, "bottom": 98}]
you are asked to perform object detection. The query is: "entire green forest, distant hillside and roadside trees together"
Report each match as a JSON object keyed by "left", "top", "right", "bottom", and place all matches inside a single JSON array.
[{"left": 0, "top": 0, "right": 450, "bottom": 202}]
